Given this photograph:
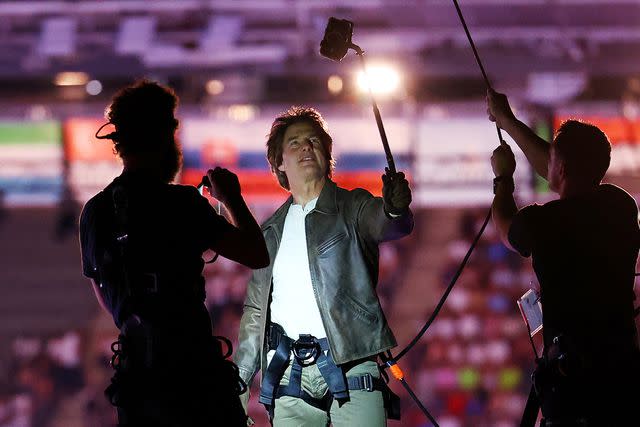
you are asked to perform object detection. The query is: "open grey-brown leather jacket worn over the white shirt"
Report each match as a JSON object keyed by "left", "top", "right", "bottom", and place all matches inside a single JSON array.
[{"left": 235, "top": 180, "right": 413, "bottom": 390}]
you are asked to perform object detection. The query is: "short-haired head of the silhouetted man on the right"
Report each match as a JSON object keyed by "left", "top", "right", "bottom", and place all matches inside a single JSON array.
[{"left": 553, "top": 120, "right": 611, "bottom": 185}]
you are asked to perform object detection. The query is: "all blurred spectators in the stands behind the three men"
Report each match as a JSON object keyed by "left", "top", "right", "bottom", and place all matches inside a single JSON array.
[{"left": 0, "top": 209, "right": 636, "bottom": 427}]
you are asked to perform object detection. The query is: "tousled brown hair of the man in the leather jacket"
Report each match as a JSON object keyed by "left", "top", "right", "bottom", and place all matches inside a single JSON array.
[{"left": 267, "top": 106, "right": 335, "bottom": 190}]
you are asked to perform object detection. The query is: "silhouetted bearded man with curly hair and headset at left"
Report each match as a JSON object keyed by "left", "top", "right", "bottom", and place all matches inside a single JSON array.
[{"left": 80, "top": 81, "right": 268, "bottom": 426}]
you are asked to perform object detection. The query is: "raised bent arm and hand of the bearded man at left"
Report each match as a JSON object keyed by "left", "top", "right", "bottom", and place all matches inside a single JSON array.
[{"left": 207, "top": 167, "right": 269, "bottom": 269}]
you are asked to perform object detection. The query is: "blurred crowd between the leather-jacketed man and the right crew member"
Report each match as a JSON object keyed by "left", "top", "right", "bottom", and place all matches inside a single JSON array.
[{"left": 402, "top": 209, "right": 539, "bottom": 427}]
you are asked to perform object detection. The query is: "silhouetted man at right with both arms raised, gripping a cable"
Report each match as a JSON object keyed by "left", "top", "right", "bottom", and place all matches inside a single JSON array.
[{"left": 487, "top": 91, "right": 640, "bottom": 426}]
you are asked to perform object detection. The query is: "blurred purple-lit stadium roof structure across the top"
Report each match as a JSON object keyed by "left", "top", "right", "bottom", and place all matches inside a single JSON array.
[{"left": 0, "top": 0, "right": 640, "bottom": 102}]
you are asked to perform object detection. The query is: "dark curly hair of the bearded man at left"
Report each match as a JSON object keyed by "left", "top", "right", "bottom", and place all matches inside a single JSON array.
[{"left": 105, "top": 79, "right": 178, "bottom": 157}]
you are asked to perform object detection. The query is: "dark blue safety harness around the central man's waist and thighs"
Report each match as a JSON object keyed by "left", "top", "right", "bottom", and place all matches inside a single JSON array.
[{"left": 260, "top": 323, "right": 386, "bottom": 415}]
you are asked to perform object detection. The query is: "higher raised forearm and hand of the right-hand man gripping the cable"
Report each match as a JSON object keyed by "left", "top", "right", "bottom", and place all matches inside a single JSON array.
[{"left": 487, "top": 89, "right": 549, "bottom": 179}]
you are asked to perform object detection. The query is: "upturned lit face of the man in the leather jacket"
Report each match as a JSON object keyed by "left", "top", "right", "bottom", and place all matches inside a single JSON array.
[{"left": 278, "top": 122, "right": 327, "bottom": 186}]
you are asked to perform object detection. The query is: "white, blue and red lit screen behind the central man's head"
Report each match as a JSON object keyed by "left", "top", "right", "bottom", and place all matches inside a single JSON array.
[{"left": 180, "top": 117, "right": 411, "bottom": 202}]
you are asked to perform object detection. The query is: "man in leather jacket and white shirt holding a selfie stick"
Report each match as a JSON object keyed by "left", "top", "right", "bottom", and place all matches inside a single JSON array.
[{"left": 234, "top": 107, "right": 413, "bottom": 427}]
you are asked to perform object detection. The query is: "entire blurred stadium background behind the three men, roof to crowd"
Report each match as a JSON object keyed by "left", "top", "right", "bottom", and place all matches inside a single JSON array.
[{"left": 0, "top": 0, "right": 640, "bottom": 427}]
